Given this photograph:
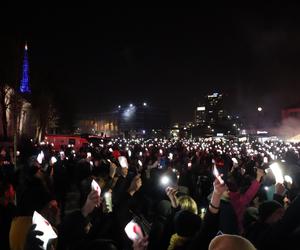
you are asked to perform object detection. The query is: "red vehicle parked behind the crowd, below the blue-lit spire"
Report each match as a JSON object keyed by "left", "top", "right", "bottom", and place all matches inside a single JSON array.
[{"left": 44, "top": 135, "right": 89, "bottom": 151}]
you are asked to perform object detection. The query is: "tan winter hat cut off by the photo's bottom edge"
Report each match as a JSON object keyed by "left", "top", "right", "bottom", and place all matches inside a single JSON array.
[{"left": 208, "top": 234, "right": 256, "bottom": 250}]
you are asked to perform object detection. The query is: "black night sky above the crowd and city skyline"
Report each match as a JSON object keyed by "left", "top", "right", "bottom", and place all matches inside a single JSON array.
[{"left": 0, "top": 7, "right": 300, "bottom": 125}]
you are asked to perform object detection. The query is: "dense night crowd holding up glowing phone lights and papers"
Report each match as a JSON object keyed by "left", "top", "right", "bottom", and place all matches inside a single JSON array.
[{"left": 0, "top": 138, "right": 300, "bottom": 250}]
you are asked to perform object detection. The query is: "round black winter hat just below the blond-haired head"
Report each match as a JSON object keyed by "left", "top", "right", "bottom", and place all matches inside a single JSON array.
[{"left": 174, "top": 210, "right": 201, "bottom": 237}]
